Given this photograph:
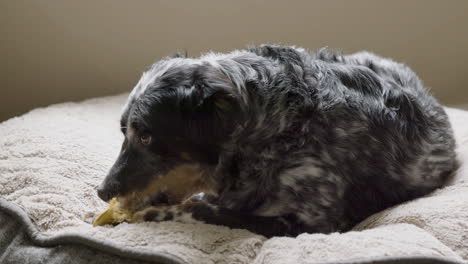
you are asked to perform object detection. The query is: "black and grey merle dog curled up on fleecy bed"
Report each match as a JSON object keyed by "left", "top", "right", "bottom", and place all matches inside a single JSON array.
[{"left": 98, "top": 45, "right": 457, "bottom": 237}]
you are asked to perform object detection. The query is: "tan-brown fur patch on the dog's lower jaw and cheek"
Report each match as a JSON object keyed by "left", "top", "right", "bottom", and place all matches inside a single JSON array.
[{"left": 115, "top": 165, "right": 215, "bottom": 212}]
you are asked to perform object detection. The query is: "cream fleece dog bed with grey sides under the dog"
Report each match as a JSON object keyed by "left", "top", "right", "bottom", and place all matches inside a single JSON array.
[{"left": 0, "top": 95, "right": 468, "bottom": 264}]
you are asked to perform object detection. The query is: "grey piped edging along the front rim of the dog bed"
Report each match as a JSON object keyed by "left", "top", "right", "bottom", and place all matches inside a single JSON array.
[{"left": 0, "top": 198, "right": 462, "bottom": 264}]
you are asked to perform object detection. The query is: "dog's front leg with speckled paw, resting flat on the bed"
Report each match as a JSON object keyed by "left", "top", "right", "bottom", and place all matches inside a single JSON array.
[{"left": 134, "top": 201, "right": 298, "bottom": 237}]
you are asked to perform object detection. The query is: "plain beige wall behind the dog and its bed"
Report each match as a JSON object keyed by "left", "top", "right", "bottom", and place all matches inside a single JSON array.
[{"left": 0, "top": 0, "right": 468, "bottom": 120}]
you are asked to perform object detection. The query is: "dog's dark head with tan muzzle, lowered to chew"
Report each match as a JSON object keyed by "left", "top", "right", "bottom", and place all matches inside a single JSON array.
[{"left": 98, "top": 58, "right": 241, "bottom": 208}]
